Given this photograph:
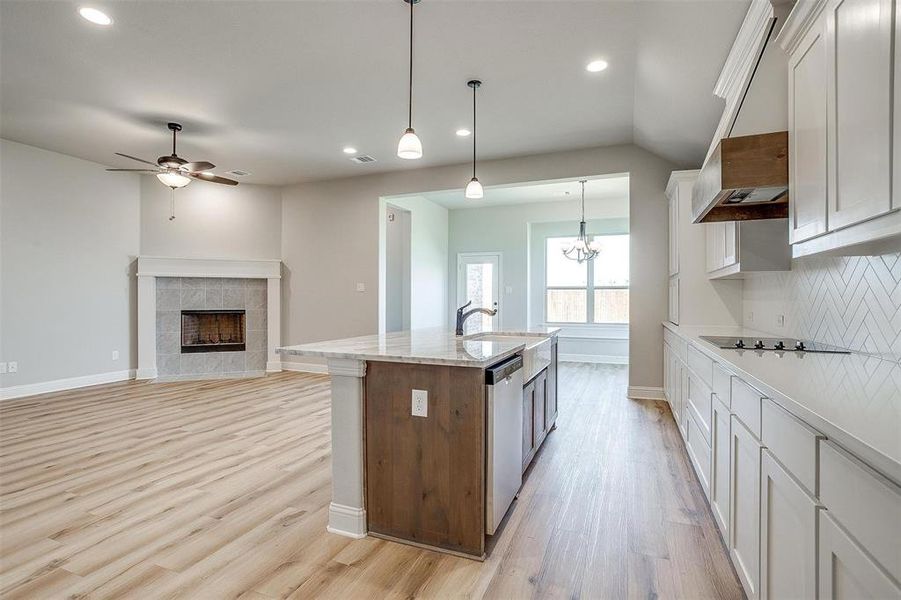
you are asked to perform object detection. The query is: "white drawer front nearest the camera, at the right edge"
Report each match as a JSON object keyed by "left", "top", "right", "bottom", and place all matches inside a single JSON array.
[{"left": 820, "top": 440, "right": 901, "bottom": 579}]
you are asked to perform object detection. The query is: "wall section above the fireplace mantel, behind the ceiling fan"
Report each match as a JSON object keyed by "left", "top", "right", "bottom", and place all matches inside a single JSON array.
[{"left": 141, "top": 176, "right": 282, "bottom": 259}]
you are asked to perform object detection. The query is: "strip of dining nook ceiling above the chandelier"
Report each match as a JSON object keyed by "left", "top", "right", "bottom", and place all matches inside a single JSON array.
[{"left": 404, "top": 175, "right": 629, "bottom": 214}]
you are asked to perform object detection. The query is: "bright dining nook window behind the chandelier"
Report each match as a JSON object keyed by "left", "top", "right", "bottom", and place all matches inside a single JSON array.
[{"left": 545, "top": 234, "right": 629, "bottom": 323}]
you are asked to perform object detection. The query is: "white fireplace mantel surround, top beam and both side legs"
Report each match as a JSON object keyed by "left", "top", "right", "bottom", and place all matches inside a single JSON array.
[{"left": 137, "top": 256, "right": 282, "bottom": 379}]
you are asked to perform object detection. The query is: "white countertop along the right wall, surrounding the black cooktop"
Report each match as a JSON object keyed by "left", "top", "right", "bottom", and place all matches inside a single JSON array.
[{"left": 664, "top": 323, "right": 901, "bottom": 485}]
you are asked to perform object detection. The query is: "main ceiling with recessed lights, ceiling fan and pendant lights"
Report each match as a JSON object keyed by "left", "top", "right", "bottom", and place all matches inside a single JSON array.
[{"left": 0, "top": 0, "right": 749, "bottom": 184}]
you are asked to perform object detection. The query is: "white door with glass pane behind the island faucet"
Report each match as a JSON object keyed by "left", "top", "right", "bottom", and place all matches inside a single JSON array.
[{"left": 454, "top": 253, "right": 501, "bottom": 333}]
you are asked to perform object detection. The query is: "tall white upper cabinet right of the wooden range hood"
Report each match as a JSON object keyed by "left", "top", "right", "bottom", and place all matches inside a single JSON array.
[{"left": 779, "top": 0, "right": 901, "bottom": 257}]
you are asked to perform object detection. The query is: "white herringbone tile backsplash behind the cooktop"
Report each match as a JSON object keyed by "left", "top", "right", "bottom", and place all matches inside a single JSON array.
[{"left": 742, "top": 253, "right": 901, "bottom": 362}]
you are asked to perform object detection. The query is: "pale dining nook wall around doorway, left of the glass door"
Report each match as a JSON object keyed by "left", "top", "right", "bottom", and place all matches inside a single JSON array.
[{"left": 379, "top": 196, "right": 448, "bottom": 329}]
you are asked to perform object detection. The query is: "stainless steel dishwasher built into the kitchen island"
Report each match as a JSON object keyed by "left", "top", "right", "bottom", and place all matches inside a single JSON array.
[{"left": 485, "top": 356, "right": 523, "bottom": 535}]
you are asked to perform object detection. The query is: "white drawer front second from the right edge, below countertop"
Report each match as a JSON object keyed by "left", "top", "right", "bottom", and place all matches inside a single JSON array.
[{"left": 760, "top": 398, "right": 824, "bottom": 496}]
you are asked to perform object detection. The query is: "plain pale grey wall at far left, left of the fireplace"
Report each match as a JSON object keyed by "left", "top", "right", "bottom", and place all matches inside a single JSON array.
[{"left": 0, "top": 140, "right": 140, "bottom": 395}]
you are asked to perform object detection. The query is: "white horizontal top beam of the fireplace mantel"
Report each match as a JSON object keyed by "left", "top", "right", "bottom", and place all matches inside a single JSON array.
[{"left": 138, "top": 256, "right": 282, "bottom": 279}]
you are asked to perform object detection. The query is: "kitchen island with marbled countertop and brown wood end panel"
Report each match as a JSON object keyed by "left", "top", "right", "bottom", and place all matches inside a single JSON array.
[{"left": 278, "top": 328, "right": 557, "bottom": 559}]
